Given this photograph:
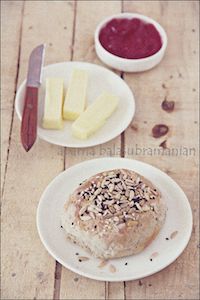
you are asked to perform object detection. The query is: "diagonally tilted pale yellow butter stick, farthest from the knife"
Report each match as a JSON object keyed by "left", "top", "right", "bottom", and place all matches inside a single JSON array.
[{"left": 72, "top": 93, "right": 119, "bottom": 139}]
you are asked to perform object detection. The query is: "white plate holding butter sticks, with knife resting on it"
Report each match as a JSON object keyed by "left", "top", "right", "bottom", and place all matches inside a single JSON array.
[{"left": 15, "top": 62, "right": 135, "bottom": 148}]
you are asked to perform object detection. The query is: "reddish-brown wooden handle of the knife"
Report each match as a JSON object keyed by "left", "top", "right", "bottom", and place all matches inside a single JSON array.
[{"left": 21, "top": 86, "right": 38, "bottom": 152}]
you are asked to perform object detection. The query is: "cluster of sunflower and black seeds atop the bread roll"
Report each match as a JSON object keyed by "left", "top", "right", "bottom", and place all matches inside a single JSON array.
[{"left": 77, "top": 170, "right": 159, "bottom": 224}]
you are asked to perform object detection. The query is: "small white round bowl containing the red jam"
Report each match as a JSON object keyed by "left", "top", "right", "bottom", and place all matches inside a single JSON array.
[{"left": 94, "top": 13, "right": 167, "bottom": 72}]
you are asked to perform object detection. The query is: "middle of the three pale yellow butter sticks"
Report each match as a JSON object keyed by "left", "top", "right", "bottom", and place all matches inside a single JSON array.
[{"left": 63, "top": 69, "right": 88, "bottom": 120}]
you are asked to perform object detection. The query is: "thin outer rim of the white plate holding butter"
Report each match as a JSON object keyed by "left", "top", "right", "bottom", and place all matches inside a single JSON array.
[{"left": 15, "top": 61, "right": 136, "bottom": 148}]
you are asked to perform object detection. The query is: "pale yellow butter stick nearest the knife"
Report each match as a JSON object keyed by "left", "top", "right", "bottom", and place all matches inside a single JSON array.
[{"left": 42, "top": 78, "right": 64, "bottom": 129}]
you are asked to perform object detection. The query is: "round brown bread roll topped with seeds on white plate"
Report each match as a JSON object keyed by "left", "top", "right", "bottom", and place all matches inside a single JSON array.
[{"left": 61, "top": 169, "right": 166, "bottom": 259}]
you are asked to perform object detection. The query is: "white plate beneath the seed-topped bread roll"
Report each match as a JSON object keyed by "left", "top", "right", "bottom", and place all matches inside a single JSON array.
[{"left": 37, "top": 158, "right": 192, "bottom": 281}]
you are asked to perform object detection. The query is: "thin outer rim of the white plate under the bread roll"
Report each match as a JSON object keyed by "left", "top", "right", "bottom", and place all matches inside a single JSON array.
[{"left": 36, "top": 157, "right": 193, "bottom": 282}]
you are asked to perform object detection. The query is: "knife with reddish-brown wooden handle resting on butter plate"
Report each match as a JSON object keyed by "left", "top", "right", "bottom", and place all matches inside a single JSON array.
[{"left": 21, "top": 45, "right": 45, "bottom": 152}]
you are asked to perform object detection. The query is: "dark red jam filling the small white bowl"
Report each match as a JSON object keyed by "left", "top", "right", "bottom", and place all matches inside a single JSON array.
[{"left": 99, "top": 18, "right": 162, "bottom": 59}]
